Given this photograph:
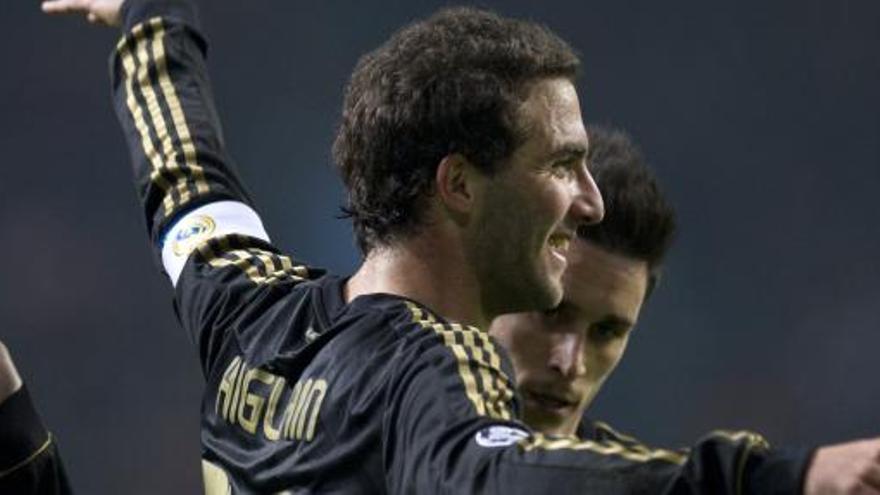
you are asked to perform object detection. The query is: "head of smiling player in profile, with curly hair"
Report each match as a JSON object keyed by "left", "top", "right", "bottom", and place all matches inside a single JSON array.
[{"left": 334, "top": 8, "right": 602, "bottom": 313}]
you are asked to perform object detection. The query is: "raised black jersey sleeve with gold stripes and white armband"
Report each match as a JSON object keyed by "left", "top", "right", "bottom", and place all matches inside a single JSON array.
[{"left": 110, "top": 0, "right": 321, "bottom": 372}]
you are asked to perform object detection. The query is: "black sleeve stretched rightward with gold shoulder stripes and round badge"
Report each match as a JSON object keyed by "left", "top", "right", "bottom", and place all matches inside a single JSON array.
[{"left": 384, "top": 306, "right": 806, "bottom": 495}]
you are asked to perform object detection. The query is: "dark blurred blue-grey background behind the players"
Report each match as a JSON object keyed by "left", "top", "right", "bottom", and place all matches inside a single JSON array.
[{"left": 0, "top": 0, "right": 880, "bottom": 494}]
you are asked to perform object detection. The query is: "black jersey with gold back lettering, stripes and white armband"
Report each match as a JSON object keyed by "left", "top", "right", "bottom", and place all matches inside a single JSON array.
[{"left": 111, "top": 0, "right": 805, "bottom": 495}]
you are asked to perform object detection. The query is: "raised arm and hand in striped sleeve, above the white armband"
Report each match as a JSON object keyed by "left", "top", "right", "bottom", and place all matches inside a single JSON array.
[{"left": 43, "top": 0, "right": 265, "bottom": 266}]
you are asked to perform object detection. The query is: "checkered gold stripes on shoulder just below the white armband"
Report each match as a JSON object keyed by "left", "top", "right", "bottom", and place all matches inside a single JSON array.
[{"left": 196, "top": 234, "right": 309, "bottom": 285}]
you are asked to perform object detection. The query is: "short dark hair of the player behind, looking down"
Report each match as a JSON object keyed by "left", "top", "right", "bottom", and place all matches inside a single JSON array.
[{"left": 578, "top": 125, "right": 676, "bottom": 293}]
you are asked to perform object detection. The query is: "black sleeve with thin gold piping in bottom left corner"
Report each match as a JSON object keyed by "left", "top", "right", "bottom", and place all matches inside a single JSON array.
[{"left": 0, "top": 386, "right": 71, "bottom": 495}]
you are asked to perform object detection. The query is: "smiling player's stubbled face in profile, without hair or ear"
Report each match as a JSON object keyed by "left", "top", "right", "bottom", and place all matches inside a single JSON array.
[{"left": 471, "top": 78, "right": 604, "bottom": 314}]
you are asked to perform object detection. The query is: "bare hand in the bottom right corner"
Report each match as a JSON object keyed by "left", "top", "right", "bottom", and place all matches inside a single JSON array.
[{"left": 804, "top": 438, "right": 880, "bottom": 495}]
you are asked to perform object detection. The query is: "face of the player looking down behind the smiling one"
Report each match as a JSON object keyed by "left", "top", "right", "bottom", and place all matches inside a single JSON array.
[{"left": 490, "top": 241, "right": 648, "bottom": 435}]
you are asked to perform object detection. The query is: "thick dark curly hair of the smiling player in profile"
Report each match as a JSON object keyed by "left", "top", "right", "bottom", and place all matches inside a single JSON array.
[{"left": 333, "top": 8, "right": 580, "bottom": 255}]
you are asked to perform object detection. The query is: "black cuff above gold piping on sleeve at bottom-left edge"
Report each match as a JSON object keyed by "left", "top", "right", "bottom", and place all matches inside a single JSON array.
[{"left": 0, "top": 385, "right": 50, "bottom": 473}]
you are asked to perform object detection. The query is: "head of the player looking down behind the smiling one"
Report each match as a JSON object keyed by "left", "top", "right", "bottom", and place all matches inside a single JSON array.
[{"left": 491, "top": 127, "right": 675, "bottom": 435}]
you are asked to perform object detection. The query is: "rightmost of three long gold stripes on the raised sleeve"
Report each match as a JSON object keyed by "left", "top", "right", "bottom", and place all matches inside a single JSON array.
[{"left": 149, "top": 17, "right": 208, "bottom": 198}]
